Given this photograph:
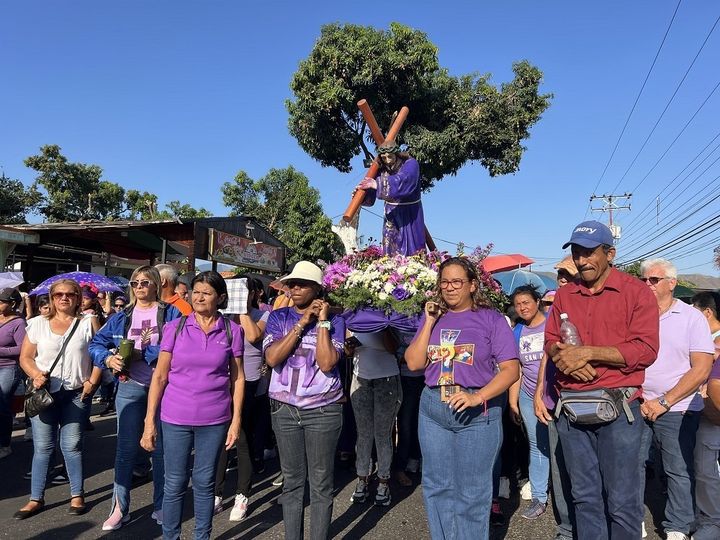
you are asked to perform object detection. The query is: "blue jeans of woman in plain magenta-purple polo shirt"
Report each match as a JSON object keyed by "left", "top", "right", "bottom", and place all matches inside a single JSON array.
[{"left": 161, "top": 422, "right": 229, "bottom": 540}]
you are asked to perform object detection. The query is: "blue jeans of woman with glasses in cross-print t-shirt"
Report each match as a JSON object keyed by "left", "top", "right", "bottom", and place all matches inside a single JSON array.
[{"left": 418, "top": 387, "right": 502, "bottom": 540}]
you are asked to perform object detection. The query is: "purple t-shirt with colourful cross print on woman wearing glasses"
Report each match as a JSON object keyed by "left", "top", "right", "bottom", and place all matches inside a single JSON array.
[{"left": 415, "top": 308, "right": 518, "bottom": 388}]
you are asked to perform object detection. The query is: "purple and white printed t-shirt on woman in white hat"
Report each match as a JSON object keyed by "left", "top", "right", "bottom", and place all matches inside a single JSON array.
[{"left": 263, "top": 307, "right": 345, "bottom": 409}]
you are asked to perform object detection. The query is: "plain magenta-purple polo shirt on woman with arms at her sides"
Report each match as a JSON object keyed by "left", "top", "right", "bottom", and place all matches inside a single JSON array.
[{"left": 160, "top": 313, "right": 244, "bottom": 426}]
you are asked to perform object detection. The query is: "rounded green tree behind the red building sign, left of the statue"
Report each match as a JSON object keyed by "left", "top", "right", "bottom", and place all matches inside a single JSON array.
[{"left": 222, "top": 167, "right": 344, "bottom": 264}]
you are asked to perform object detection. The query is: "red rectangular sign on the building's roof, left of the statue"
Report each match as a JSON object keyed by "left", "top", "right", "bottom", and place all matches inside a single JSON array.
[{"left": 208, "top": 229, "right": 283, "bottom": 272}]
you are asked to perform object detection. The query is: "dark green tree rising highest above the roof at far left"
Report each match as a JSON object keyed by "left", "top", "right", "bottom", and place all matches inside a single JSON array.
[{"left": 25, "top": 144, "right": 125, "bottom": 222}]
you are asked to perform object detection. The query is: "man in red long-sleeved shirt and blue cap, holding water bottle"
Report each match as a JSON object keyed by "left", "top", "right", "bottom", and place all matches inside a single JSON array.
[{"left": 545, "top": 221, "right": 659, "bottom": 540}]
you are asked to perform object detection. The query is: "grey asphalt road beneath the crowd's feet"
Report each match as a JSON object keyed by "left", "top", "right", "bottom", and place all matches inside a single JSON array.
[{"left": 0, "top": 405, "right": 661, "bottom": 540}]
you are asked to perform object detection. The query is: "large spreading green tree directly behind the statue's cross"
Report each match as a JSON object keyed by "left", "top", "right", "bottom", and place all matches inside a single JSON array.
[{"left": 286, "top": 23, "right": 552, "bottom": 189}]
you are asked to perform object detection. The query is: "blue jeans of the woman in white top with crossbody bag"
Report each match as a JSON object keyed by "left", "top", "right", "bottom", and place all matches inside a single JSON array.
[{"left": 30, "top": 389, "right": 91, "bottom": 501}]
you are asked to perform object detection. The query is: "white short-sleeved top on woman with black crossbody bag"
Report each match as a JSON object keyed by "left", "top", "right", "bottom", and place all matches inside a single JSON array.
[{"left": 26, "top": 315, "right": 93, "bottom": 392}]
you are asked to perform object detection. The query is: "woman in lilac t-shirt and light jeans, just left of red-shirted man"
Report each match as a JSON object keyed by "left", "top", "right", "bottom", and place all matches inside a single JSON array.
[{"left": 509, "top": 285, "right": 550, "bottom": 519}]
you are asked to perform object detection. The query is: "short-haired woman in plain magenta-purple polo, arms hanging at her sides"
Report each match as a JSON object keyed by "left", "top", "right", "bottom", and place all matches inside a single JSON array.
[{"left": 140, "top": 270, "right": 245, "bottom": 540}]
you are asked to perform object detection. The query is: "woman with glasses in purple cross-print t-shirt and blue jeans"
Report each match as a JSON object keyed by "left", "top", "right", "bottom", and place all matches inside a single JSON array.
[{"left": 405, "top": 257, "right": 520, "bottom": 540}]
